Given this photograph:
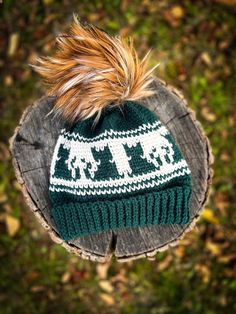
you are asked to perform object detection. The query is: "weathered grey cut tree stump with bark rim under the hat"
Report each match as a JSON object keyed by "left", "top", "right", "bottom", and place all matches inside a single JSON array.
[{"left": 10, "top": 78, "right": 213, "bottom": 262}]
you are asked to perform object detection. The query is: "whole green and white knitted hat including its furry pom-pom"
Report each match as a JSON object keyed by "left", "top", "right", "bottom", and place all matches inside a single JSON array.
[{"left": 32, "top": 16, "right": 192, "bottom": 240}]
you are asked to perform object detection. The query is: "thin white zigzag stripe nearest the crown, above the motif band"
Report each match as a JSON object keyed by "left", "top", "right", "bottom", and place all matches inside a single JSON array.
[{"left": 61, "top": 121, "right": 162, "bottom": 142}]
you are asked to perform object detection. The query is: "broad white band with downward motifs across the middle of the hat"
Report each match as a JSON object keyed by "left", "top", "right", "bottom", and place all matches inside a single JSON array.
[{"left": 50, "top": 122, "right": 174, "bottom": 185}]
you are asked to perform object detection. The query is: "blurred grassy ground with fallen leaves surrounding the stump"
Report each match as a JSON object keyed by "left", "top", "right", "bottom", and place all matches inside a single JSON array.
[{"left": 0, "top": 0, "right": 236, "bottom": 314}]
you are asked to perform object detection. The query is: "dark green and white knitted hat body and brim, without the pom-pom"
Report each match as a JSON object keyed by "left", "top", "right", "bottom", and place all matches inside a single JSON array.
[{"left": 49, "top": 101, "right": 191, "bottom": 240}]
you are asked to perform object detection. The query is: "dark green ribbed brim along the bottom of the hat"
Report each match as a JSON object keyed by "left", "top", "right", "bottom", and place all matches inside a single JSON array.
[{"left": 52, "top": 185, "right": 191, "bottom": 241}]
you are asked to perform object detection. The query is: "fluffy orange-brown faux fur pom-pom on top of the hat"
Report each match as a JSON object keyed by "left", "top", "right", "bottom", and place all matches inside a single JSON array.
[{"left": 33, "top": 16, "right": 158, "bottom": 123}]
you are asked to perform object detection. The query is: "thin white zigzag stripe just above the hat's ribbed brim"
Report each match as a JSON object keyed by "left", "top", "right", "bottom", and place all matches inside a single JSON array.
[{"left": 49, "top": 168, "right": 190, "bottom": 196}]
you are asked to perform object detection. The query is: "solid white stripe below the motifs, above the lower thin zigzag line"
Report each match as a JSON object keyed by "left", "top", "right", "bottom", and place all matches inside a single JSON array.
[{"left": 50, "top": 159, "right": 189, "bottom": 189}]
